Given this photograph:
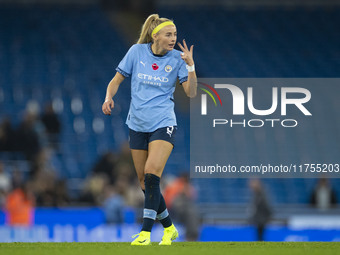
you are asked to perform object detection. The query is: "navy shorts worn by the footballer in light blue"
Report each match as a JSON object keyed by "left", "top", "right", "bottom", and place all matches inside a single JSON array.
[{"left": 129, "top": 126, "right": 177, "bottom": 150}]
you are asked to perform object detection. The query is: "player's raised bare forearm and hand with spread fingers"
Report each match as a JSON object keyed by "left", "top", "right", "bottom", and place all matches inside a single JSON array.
[{"left": 178, "top": 40, "right": 197, "bottom": 98}]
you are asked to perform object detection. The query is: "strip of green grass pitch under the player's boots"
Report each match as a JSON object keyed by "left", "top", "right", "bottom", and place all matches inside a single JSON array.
[{"left": 0, "top": 242, "right": 340, "bottom": 255}]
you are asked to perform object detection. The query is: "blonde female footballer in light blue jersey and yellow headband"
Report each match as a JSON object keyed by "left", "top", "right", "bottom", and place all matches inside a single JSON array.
[{"left": 102, "top": 14, "right": 197, "bottom": 245}]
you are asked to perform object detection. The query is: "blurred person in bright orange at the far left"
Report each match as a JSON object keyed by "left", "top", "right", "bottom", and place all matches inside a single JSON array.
[{"left": 5, "top": 183, "right": 34, "bottom": 226}]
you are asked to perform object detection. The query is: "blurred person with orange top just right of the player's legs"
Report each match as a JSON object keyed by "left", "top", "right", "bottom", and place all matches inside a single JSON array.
[{"left": 163, "top": 173, "right": 200, "bottom": 241}]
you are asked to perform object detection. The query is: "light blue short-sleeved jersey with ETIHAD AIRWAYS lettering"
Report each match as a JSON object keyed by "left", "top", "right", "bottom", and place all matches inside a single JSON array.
[{"left": 116, "top": 43, "right": 188, "bottom": 132}]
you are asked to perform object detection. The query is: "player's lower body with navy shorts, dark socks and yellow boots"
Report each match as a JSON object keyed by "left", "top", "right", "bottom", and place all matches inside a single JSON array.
[{"left": 130, "top": 127, "right": 178, "bottom": 245}]
